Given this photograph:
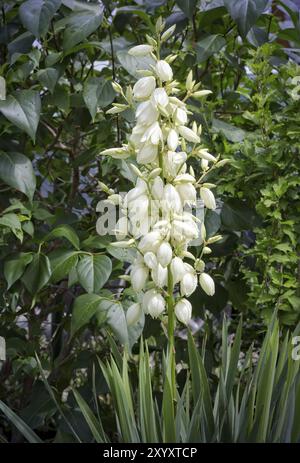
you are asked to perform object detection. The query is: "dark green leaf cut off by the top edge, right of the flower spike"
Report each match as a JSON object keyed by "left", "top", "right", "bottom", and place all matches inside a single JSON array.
[{"left": 224, "top": 0, "right": 269, "bottom": 37}]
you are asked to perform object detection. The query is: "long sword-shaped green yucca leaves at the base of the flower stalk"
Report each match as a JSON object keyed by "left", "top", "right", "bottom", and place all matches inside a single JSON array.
[{"left": 24, "top": 317, "right": 300, "bottom": 443}]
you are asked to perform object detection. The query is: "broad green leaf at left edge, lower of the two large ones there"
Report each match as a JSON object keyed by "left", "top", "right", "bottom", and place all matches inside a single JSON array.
[{"left": 0, "top": 152, "right": 36, "bottom": 200}]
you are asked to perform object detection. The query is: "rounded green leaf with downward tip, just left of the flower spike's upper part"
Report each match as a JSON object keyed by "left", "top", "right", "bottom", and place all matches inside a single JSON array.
[{"left": 83, "top": 77, "right": 115, "bottom": 120}]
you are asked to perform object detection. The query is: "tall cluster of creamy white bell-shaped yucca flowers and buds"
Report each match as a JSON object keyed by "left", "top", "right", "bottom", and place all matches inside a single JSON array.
[{"left": 101, "top": 21, "right": 224, "bottom": 330}]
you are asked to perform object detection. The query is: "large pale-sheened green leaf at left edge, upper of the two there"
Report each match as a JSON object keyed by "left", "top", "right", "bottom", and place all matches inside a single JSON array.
[{"left": 0, "top": 90, "right": 41, "bottom": 141}]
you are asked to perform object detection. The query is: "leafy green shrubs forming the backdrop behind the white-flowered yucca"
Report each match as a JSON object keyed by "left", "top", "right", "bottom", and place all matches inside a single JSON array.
[{"left": 0, "top": 0, "right": 300, "bottom": 442}]
